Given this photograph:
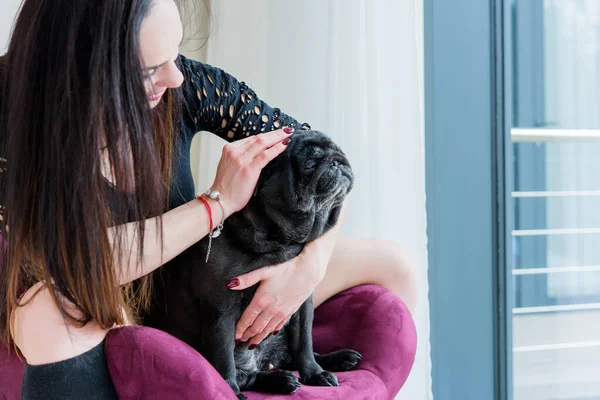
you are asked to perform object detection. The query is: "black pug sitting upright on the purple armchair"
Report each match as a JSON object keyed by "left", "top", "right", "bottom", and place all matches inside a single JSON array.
[{"left": 144, "top": 131, "right": 361, "bottom": 399}]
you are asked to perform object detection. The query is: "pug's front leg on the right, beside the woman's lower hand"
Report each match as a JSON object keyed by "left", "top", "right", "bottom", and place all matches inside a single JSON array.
[{"left": 285, "top": 296, "right": 338, "bottom": 386}]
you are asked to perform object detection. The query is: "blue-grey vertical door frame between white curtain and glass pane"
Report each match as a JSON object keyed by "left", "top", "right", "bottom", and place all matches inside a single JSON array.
[{"left": 424, "top": 0, "right": 512, "bottom": 400}]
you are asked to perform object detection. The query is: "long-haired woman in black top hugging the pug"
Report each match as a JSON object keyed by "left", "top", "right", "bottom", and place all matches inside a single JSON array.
[{"left": 0, "top": 0, "right": 416, "bottom": 398}]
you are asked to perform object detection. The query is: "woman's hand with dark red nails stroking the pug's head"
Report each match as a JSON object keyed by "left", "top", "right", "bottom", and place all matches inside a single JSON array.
[{"left": 211, "top": 128, "right": 294, "bottom": 218}]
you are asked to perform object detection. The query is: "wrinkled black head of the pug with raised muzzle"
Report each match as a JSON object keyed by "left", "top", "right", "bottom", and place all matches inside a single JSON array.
[{"left": 256, "top": 131, "right": 354, "bottom": 242}]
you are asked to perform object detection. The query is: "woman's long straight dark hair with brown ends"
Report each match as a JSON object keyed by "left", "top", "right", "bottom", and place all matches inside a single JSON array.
[{"left": 0, "top": 0, "right": 177, "bottom": 343}]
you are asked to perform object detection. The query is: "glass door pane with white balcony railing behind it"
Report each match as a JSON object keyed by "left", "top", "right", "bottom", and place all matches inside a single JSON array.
[{"left": 505, "top": 0, "right": 600, "bottom": 400}]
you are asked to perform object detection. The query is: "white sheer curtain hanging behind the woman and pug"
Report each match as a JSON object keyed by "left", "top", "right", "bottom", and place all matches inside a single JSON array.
[{"left": 194, "top": 0, "right": 431, "bottom": 400}]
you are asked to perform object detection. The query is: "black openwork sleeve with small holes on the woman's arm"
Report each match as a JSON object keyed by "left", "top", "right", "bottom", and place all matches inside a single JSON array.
[{"left": 178, "top": 56, "right": 310, "bottom": 142}]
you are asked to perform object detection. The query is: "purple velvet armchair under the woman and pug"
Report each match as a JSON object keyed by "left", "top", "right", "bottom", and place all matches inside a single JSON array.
[{"left": 0, "top": 285, "right": 417, "bottom": 400}]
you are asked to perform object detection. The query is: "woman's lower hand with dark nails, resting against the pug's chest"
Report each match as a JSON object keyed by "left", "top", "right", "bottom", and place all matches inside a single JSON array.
[{"left": 227, "top": 251, "right": 325, "bottom": 349}]
